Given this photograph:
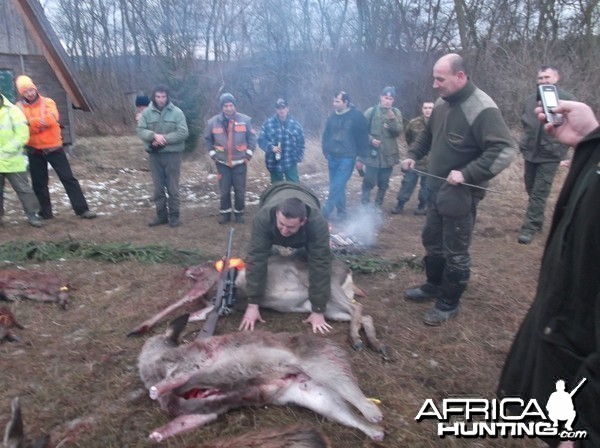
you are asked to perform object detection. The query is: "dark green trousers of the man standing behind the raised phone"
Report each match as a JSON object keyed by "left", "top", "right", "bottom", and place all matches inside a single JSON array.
[{"left": 521, "top": 161, "right": 558, "bottom": 231}]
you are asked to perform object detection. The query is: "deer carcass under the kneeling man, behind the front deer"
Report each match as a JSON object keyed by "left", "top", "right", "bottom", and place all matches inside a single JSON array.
[{"left": 128, "top": 255, "right": 387, "bottom": 359}]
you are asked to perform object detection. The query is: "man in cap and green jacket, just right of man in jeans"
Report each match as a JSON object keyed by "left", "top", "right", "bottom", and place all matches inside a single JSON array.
[{"left": 356, "top": 87, "right": 403, "bottom": 208}]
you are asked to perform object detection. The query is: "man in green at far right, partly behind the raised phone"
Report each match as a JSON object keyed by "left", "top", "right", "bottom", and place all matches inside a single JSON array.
[{"left": 517, "top": 65, "right": 574, "bottom": 244}]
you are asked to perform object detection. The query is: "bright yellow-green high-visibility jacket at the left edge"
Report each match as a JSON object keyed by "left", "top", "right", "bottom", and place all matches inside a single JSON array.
[{"left": 0, "top": 95, "right": 29, "bottom": 174}]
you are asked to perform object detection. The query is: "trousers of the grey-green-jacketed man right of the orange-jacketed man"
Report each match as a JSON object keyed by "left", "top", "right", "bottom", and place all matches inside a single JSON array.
[{"left": 149, "top": 152, "right": 182, "bottom": 220}]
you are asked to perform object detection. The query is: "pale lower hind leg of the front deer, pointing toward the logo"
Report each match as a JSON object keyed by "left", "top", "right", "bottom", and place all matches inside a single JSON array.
[{"left": 275, "top": 379, "right": 384, "bottom": 441}]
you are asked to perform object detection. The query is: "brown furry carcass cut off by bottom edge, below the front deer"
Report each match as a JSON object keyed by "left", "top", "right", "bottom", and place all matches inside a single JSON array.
[{"left": 195, "top": 425, "right": 331, "bottom": 448}]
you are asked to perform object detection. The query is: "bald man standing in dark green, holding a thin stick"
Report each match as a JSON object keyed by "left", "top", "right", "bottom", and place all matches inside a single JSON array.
[{"left": 402, "top": 53, "right": 516, "bottom": 326}]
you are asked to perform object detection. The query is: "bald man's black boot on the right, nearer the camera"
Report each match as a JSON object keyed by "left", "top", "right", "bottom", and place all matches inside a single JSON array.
[{"left": 423, "top": 271, "right": 470, "bottom": 326}]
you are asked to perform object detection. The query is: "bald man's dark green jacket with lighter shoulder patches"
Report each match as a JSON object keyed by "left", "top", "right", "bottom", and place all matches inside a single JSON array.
[{"left": 408, "top": 81, "right": 516, "bottom": 196}]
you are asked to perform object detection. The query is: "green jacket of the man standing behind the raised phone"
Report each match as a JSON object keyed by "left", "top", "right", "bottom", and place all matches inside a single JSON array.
[{"left": 519, "top": 90, "right": 575, "bottom": 163}]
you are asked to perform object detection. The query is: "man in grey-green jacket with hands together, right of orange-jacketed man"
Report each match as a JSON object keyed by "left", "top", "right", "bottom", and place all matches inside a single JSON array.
[{"left": 137, "top": 85, "right": 188, "bottom": 227}]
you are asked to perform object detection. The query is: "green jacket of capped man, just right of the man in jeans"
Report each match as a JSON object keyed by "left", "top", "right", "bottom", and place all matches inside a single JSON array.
[{"left": 359, "top": 106, "right": 403, "bottom": 168}]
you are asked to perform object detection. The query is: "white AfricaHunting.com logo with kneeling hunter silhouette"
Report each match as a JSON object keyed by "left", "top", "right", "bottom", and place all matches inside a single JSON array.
[{"left": 415, "top": 378, "right": 588, "bottom": 440}]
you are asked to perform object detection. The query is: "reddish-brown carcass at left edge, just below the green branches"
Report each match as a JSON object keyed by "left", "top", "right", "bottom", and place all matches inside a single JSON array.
[{"left": 0, "top": 269, "right": 71, "bottom": 309}]
